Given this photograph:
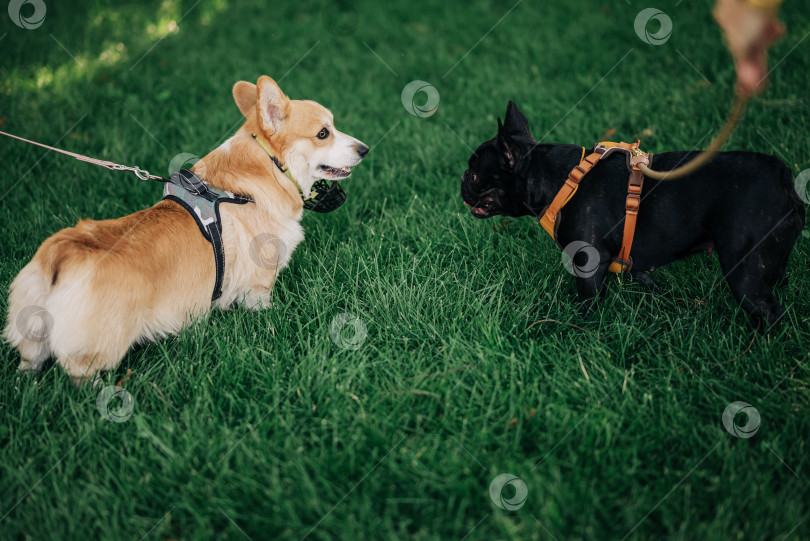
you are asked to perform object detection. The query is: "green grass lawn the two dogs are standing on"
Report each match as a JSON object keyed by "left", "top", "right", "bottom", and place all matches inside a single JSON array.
[{"left": 0, "top": 0, "right": 810, "bottom": 541}]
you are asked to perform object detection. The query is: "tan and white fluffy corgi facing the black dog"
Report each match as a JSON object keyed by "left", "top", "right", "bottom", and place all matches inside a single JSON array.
[{"left": 4, "top": 76, "right": 368, "bottom": 383}]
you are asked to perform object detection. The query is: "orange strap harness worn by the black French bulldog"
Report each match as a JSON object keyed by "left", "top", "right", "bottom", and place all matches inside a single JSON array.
[{"left": 540, "top": 141, "right": 652, "bottom": 274}]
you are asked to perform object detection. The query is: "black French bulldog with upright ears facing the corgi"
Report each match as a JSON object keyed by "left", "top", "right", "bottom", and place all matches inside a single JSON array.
[{"left": 461, "top": 101, "right": 805, "bottom": 330}]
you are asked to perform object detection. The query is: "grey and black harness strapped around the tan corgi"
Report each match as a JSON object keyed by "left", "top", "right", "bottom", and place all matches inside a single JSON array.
[{"left": 163, "top": 169, "right": 253, "bottom": 302}]
